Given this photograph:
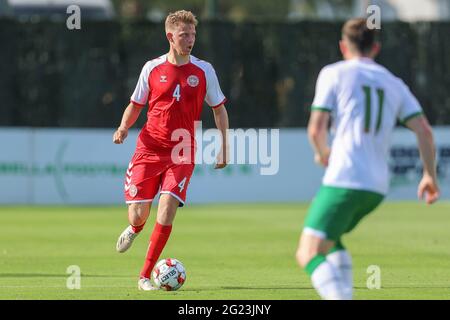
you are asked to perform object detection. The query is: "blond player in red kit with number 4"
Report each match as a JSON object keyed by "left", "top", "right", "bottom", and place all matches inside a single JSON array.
[{"left": 113, "top": 10, "right": 228, "bottom": 290}]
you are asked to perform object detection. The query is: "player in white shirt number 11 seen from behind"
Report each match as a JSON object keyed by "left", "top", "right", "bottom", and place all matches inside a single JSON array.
[{"left": 296, "top": 19, "right": 439, "bottom": 299}]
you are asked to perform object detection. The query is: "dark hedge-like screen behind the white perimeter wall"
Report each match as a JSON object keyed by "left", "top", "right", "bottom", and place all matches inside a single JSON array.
[{"left": 0, "top": 19, "right": 450, "bottom": 128}]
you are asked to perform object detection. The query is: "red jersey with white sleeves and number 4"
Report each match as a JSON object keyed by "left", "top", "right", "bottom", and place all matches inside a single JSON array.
[{"left": 131, "top": 55, "right": 226, "bottom": 156}]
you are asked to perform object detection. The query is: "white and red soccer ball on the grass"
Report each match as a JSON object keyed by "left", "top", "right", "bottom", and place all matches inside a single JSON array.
[{"left": 152, "top": 259, "right": 186, "bottom": 291}]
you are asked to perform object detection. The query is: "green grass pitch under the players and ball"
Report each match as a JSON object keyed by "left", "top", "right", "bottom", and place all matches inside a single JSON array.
[{"left": 0, "top": 202, "right": 450, "bottom": 300}]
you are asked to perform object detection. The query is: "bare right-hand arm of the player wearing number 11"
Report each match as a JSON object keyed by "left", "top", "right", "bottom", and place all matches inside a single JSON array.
[{"left": 406, "top": 115, "right": 439, "bottom": 204}]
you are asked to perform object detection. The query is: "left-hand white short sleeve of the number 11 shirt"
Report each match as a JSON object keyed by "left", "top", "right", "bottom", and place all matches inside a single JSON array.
[{"left": 311, "top": 67, "right": 336, "bottom": 111}]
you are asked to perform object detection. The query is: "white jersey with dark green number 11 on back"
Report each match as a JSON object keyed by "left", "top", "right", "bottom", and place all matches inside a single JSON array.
[{"left": 312, "top": 58, "right": 422, "bottom": 194}]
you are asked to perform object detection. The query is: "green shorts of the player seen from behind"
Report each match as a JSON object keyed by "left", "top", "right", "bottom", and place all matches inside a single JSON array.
[{"left": 305, "top": 186, "right": 384, "bottom": 241}]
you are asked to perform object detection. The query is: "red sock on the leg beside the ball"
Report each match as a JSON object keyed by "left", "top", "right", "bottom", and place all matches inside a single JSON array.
[{"left": 141, "top": 222, "right": 172, "bottom": 278}]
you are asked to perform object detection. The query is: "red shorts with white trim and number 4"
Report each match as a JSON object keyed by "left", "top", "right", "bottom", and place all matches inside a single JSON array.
[{"left": 125, "top": 153, "right": 195, "bottom": 207}]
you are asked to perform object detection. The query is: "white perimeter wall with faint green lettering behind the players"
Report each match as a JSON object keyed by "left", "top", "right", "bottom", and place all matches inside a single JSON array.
[{"left": 0, "top": 127, "right": 450, "bottom": 205}]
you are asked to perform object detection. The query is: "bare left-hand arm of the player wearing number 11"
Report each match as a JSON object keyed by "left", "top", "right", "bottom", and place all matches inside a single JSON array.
[{"left": 308, "top": 110, "right": 330, "bottom": 167}]
